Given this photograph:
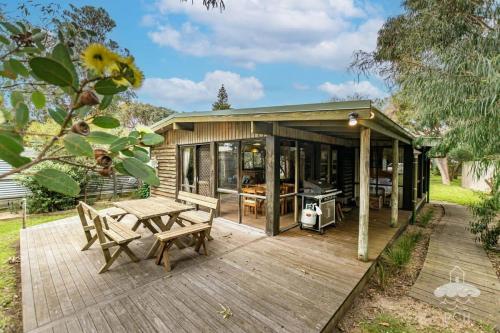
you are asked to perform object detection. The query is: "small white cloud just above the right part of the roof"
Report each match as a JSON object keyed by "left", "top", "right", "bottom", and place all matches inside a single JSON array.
[{"left": 318, "top": 81, "right": 387, "bottom": 98}]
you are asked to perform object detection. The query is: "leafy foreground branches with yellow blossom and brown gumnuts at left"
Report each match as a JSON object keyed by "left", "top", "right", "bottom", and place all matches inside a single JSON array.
[{"left": 0, "top": 11, "right": 163, "bottom": 196}]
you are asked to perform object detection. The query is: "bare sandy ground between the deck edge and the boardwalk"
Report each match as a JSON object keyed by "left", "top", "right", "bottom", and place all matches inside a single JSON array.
[{"left": 337, "top": 204, "right": 490, "bottom": 333}]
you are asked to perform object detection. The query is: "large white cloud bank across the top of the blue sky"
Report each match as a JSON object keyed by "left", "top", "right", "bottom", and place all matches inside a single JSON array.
[{"left": 149, "top": 0, "right": 384, "bottom": 70}]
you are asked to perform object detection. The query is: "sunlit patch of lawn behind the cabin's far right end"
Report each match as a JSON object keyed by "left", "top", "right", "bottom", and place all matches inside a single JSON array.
[{"left": 430, "top": 175, "right": 480, "bottom": 206}]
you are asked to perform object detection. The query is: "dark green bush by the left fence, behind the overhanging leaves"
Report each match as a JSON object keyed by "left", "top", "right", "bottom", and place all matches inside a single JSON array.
[{"left": 18, "top": 162, "right": 87, "bottom": 213}]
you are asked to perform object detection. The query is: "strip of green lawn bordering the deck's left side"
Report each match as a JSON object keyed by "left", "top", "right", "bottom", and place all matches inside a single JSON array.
[{"left": 0, "top": 203, "right": 110, "bottom": 332}]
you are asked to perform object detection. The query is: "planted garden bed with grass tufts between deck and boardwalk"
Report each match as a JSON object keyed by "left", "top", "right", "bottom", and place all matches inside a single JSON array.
[{"left": 338, "top": 204, "right": 492, "bottom": 333}]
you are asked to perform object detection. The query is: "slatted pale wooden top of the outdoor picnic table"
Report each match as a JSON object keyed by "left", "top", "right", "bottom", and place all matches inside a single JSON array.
[{"left": 113, "top": 197, "right": 193, "bottom": 220}]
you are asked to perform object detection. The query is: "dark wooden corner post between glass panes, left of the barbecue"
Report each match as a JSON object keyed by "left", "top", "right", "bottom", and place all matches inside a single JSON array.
[{"left": 266, "top": 135, "right": 280, "bottom": 236}]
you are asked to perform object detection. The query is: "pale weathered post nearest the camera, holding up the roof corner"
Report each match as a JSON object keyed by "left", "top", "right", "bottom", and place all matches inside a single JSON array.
[{"left": 358, "top": 127, "right": 370, "bottom": 261}]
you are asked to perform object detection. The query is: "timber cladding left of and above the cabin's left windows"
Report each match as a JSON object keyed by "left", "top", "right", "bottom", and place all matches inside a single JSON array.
[{"left": 151, "top": 122, "right": 265, "bottom": 198}]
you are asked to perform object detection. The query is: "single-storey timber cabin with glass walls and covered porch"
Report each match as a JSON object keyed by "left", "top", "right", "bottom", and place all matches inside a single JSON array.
[{"left": 148, "top": 100, "right": 430, "bottom": 260}]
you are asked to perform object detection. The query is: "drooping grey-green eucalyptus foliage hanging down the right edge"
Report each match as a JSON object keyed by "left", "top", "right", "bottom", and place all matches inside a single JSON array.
[{"left": 352, "top": 0, "right": 500, "bottom": 246}]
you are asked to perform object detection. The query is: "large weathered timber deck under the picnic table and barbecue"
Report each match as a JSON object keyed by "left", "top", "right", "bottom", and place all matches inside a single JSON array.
[{"left": 21, "top": 206, "right": 410, "bottom": 333}]
